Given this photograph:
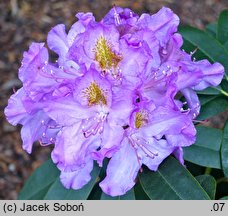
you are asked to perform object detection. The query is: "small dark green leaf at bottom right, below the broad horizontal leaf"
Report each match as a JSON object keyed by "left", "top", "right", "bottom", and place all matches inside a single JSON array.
[{"left": 195, "top": 175, "right": 216, "bottom": 200}]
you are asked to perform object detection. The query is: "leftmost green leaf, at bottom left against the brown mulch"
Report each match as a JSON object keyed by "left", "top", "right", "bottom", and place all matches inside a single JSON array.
[{"left": 18, "top": 159, "right": 60, "bottom": 200}]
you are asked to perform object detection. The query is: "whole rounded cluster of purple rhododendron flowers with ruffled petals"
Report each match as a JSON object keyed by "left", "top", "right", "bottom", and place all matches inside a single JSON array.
[{"left": 5, "top": 7, "right": 224, "bottom": 196}]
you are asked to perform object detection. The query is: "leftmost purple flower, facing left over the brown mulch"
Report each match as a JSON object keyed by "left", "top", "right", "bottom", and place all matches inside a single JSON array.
[{"left": 5, "top": 87, "right": 59, "bottom": 153}]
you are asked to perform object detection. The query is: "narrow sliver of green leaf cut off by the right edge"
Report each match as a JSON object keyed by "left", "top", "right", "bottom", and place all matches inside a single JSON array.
[{"left": 221, "top": 120, "right": 228, "bottom": 177}]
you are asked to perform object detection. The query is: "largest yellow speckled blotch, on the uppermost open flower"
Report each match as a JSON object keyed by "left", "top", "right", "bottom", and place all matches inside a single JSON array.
[{"left": 94, "top": 36, "right": 122, "bottom": 70}]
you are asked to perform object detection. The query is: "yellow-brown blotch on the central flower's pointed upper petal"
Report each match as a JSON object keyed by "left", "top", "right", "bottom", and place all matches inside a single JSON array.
[{"left": 82, "top": 82, "right": 107, "bottom": 106}]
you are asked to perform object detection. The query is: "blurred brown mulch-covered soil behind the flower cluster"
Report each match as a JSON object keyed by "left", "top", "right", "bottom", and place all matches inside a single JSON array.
[{"left": 0, "top": 0, "right": 228, "bottom": 199}]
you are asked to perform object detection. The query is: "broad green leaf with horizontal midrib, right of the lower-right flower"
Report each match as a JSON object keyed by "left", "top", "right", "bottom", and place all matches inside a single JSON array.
[{"left": 184, "top": 126, "right": 222, "bottom": 169}]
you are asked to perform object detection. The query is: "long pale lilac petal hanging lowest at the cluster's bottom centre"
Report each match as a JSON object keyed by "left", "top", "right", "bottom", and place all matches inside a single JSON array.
[{"left": 99, "top": 139, "right": 141, "bottom": 196}]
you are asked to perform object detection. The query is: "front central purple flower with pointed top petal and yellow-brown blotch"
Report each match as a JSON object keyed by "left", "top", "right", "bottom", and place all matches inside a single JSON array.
[{"left": 44, "top": 68, "right": 132, "bottom": 189}]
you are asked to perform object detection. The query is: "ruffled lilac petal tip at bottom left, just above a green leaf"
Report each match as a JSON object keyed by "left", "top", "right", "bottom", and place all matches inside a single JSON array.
[{"left": 60, "top": 159, "right": 93, "bottom": 190}]
